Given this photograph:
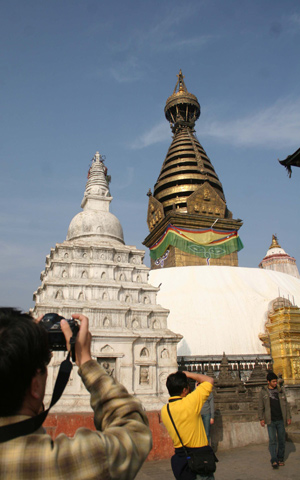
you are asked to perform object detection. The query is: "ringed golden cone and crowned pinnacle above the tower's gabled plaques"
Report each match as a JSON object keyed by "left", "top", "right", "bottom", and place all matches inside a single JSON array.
[{"left": 153, "top": 70, "right": 226, "bottom": 218}]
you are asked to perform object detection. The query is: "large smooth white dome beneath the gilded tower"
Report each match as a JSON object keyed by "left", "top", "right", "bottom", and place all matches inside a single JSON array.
[{"left": 149, "top": 266, "right": 300, "bottom": 356}]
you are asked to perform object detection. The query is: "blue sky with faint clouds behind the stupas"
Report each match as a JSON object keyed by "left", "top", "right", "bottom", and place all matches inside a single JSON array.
[{"left": 0, "top": 0, "right": 300, "bottom": 310}]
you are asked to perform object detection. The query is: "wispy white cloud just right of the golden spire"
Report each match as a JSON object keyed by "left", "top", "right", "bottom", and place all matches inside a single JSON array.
[{"left": 201, "top": 98, "right": 300, "bottom": 147}]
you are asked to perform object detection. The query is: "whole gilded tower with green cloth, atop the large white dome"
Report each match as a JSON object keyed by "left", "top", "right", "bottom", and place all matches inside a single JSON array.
[{"left": 144, "top": 70, "right": 243, "bottom": 269}]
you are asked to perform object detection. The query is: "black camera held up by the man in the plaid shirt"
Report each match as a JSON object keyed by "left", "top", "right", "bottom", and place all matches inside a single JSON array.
[{"left": 40, "top": 313, "right": 79, "bottom": 351}]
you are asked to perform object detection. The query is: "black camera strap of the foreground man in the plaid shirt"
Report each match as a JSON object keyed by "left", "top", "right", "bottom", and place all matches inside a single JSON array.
[{"left": 0, "top": 353, "right": 73, "bottom": 443}]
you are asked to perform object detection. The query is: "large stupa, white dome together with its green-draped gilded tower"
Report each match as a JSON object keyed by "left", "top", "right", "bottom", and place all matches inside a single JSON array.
[{"left": 144, "top": 70, "right": 300, "bottom": 368}]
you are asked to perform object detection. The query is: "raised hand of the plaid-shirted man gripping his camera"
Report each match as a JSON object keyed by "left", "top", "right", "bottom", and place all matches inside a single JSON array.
[{"left": 60, "top": 313, "right": 92, "bottom": 367}]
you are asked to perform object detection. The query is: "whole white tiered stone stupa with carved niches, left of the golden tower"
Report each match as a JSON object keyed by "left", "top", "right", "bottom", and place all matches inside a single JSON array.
[{"left": 33, "top": 152, "right": 181, "bottom": 412}]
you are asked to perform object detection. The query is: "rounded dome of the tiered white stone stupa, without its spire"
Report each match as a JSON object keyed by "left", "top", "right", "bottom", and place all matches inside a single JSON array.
[{"left": 67, "top": 210, "right": 124, "bottom": 244}]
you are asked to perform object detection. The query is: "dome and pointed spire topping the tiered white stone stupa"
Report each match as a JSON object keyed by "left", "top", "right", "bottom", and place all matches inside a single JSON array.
[{"left": 67, "top": 152, "right": 124, "bottom": 245}]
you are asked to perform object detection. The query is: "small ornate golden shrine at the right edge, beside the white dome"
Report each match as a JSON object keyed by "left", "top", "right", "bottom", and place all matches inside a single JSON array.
[{"left": 259, "top": 297, "right": 300, "bottom": 385}]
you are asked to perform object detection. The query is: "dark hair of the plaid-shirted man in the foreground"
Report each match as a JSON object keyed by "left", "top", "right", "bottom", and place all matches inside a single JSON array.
[{"left": 0, "top": 307, "right": 51, "bottom": 417}]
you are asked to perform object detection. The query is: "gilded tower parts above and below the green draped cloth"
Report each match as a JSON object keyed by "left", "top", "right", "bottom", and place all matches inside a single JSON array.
[{"left": 144, "top": 70, "right": 242, "bottom": 268}]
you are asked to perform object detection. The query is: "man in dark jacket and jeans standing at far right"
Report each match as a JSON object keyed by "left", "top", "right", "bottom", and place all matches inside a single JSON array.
[{"left": 258, "top": 372, "right": 291, "bottom": 468}]
